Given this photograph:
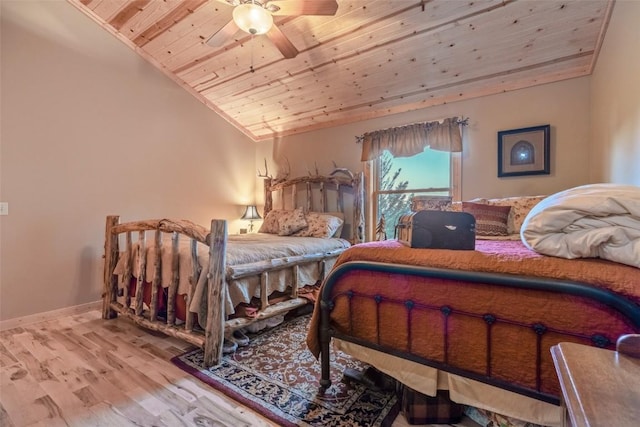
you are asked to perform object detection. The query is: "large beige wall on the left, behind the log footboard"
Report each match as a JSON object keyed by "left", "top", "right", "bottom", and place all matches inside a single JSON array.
[{"left": 0, "top": 0, "right": 255, "bottom": 320}]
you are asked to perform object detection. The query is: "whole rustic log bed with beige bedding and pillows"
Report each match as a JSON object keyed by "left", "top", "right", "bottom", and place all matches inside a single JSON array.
[{"left": 103, "top": 171, "right": 364, "bottom": 365}]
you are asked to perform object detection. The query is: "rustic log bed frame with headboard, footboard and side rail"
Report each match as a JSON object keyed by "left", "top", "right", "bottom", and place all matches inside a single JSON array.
[{"left": 102, "top": 171, "right": 364, "bottom": 366}]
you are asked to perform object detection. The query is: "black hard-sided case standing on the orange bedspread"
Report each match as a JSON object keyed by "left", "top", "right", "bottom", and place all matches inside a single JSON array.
[{"left": 396, "top": 210, "right": 476, "bottom": 250}]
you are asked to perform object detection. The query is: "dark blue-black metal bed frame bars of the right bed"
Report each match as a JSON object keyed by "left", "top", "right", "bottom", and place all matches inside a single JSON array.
[{"left": 317, "top": 261, "right": 640, "bottom": 405}]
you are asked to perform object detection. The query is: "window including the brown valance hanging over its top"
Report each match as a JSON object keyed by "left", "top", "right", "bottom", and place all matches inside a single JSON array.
[{"left": 358, "top": 117, "right": 468, "bottom": 240}]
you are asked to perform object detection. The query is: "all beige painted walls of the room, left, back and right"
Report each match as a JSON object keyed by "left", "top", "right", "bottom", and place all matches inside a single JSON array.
[{"left": 0, "top": 0, "right": 640, "bottom": 320}]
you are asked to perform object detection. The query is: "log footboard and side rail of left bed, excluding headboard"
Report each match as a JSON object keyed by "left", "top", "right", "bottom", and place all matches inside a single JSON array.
[{"left": 102, "top": 216, "right": 342, "bottom": 366}]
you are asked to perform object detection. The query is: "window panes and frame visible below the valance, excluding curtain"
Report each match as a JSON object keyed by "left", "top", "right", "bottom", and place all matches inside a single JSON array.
[{"left": 368, "top": 148, "right": 460, "bottom": 240}]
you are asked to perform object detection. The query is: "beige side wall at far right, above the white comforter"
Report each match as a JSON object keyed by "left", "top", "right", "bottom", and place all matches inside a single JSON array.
[{"left": 589, "top": 0, "right": 640, "bottom": 186}]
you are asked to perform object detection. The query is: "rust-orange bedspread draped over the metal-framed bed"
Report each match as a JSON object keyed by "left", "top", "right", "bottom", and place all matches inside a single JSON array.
[{"left": 307, "top": 240, "right": 640, "bottom": 396}]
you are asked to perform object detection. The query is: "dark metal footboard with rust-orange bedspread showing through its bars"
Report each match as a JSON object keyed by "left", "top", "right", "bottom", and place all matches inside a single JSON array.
[{"left": 317, "top": 261, "right": 640, "bottom": 405}]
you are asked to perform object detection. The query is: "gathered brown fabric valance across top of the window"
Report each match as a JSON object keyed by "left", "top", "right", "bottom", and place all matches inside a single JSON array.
[{"left": 358, "top": 117, "right": 468, "bottom": 162}]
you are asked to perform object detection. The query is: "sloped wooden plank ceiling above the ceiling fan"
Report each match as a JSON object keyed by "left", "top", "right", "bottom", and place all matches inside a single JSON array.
[{"left": 68, "top": 0, "right": 614, "bottom": 141}]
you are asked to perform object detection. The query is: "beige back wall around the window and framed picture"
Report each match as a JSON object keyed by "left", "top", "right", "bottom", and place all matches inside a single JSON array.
[{"left": 256, "top": 77, "right": 589, "bottom": 199}]
